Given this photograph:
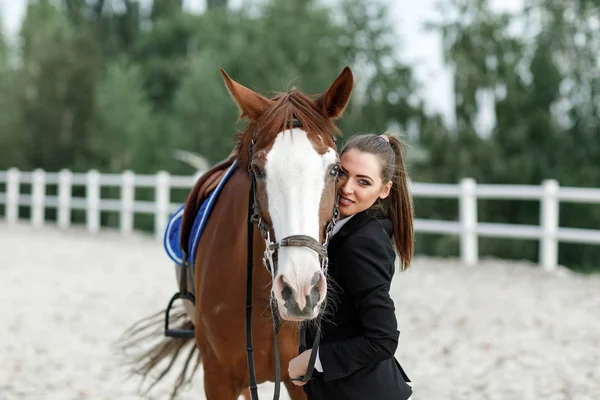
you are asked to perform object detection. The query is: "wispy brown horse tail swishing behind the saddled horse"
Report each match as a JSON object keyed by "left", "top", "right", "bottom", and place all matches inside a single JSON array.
[{"left": 115, "top": 306, "right": 201, "bottom": 400}]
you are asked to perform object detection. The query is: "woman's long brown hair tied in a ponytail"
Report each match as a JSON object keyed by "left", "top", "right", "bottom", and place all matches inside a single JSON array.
[{"left": 340, "top": 134, "right": 414, "bottom": 270}]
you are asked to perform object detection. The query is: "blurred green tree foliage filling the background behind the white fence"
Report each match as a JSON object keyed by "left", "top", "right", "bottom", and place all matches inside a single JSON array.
[{"left": 0, "top": 0, "right": 600, "bottom": 267}]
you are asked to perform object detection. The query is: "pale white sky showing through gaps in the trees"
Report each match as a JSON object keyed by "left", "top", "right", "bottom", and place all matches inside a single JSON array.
[{"left": 0, "top": 0, "right": 523, "bottom": 131}]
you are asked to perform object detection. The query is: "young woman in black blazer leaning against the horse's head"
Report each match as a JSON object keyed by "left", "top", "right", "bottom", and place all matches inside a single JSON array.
[{"left": 288, "top": 134, "right": 413, "bottom": 400}]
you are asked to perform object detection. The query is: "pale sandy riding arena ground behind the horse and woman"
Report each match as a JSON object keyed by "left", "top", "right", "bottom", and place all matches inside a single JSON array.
[{"left": 0, "top": 223, "right": 600, "bottom": 400}]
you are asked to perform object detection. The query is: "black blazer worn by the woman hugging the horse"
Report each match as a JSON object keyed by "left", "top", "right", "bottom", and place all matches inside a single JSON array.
[{"left": 304, "top": 209, "right": 412, "bottom": 400}]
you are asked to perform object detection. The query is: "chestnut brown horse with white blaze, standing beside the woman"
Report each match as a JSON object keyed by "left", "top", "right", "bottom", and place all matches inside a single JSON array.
[{"left": 119, "top": 67, "right": 354, "bottom": 400}]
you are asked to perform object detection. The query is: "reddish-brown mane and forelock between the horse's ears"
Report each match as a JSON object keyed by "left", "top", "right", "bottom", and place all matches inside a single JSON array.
[{"left": 234, "top": 89, "right": 341, "bottom": 167}]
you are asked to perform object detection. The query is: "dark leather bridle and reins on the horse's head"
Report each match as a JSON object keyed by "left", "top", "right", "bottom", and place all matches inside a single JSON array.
[{"left": 246, "top": 119, "right": 339, "bottom": 400}]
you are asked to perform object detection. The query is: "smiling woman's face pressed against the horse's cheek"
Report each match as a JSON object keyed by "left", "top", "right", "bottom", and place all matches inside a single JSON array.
[{"left": 337, "top": 149, "right": 392, "bottom": 218}]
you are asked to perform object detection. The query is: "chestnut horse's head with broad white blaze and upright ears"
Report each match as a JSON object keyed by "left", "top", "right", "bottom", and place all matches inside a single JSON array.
[{"left": 221, "top": 67, "right": 354, "bottom": 321}]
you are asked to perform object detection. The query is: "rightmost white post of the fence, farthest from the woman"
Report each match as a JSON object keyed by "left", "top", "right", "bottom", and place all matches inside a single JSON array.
[{"left": 540, "top": 179, "right": 559, "bottom": 271}]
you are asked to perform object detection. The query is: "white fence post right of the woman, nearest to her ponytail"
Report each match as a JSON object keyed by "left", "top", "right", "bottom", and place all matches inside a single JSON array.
[{"left": 459, "top": 178, "right": 479, "bottom": 265}]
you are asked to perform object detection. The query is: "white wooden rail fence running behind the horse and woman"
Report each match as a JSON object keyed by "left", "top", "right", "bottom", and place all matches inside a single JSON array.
[{"left": 0, "top": 169, "right": 600, "bottom": 270}]
